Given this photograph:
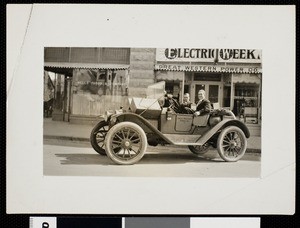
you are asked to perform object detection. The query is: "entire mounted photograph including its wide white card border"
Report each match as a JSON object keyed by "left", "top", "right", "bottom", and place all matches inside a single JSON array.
[{"left": 6, "top": 4, "right": 296, "bottom": 216}]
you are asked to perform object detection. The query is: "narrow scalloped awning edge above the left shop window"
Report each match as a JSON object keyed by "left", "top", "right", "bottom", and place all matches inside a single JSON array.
[{"left": 44, "top": 62, "right": 129, "bottom": 70}]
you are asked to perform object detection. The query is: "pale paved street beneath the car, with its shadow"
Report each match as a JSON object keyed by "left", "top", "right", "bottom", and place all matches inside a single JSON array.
[{"left": 43, "top": 139, "right": 261, "bottom": 177}]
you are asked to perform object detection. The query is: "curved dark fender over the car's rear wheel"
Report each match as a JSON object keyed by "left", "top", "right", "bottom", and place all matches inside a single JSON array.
[{"left": 197, "top": 119, "right": 250, "bottom": 145}]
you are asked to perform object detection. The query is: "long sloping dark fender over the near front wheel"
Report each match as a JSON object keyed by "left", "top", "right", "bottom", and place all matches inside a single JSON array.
[{"left": 110, "top": 112, "right": 173, "bottom": 144}]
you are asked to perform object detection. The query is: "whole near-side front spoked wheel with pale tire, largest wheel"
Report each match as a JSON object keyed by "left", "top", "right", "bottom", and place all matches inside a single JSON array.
[{"left": 105, "top": 122, "right": 147, "bottom": 165}]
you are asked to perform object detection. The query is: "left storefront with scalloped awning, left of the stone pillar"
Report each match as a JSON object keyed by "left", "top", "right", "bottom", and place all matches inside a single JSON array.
[{"left": 44, "top": 48, "right": 130, "bottom": 123}]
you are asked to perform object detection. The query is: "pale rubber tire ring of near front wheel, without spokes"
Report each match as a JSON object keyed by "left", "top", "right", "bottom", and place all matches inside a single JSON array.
[{"left": 105, "top": 122, "right": 147, "bottom": 165}]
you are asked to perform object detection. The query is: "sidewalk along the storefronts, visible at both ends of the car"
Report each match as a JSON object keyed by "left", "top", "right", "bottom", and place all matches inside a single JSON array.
[{"left": 44, "top": 118, "right": 261, "bottom": 153}]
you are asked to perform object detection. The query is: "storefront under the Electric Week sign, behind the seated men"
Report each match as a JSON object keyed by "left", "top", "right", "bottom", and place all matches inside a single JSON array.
[{"left": 155, "top": 48, "right": 262, "bottom": 123}]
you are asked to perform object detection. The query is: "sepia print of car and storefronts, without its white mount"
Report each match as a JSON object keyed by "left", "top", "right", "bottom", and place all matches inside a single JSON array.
[{"left": 43, "top": 47, "right": 263, "bottom": 177}]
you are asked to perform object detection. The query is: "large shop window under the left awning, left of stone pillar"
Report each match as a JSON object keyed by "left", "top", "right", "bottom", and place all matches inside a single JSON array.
[{"left": 72, "top": 70, "right": 129, "bottom": 116}]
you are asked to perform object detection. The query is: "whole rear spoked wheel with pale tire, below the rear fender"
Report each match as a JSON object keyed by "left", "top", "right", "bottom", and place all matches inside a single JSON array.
[{"left": 217, "top": 126, "right": 247, "bottom": 162}]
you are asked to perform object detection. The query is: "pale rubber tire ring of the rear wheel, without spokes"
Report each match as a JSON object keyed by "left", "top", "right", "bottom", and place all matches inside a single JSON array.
[{"left": 217, "top": 126, "right": 247, "bottom": 162}]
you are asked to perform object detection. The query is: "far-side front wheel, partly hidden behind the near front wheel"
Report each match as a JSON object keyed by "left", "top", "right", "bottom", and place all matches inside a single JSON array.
[{"left": 90, "top": 121, "right": 109, "bottom": 155}]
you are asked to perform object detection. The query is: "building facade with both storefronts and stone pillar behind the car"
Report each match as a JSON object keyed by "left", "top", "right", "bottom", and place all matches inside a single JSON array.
[{"left": 44, "top": 48, "right": 262, "bottom": 123}]
